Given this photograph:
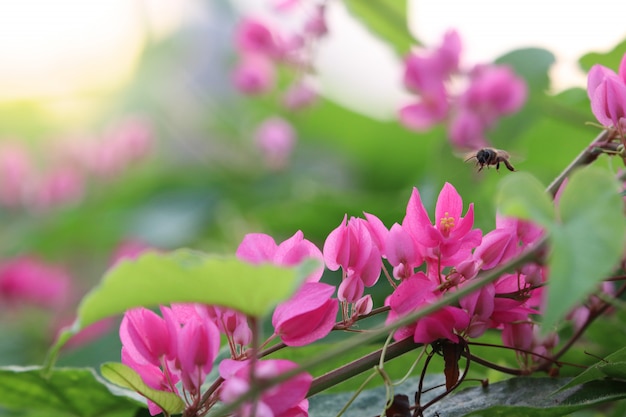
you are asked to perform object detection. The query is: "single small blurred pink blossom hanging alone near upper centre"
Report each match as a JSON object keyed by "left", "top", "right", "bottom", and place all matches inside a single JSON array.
[{"left": 254, "top": 117, "right": 296, "bottom": 170}]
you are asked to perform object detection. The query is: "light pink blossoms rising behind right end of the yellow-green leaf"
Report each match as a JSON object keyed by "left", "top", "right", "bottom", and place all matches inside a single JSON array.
[{"left": 237, "top": 230, "right": 324, "bottom": 282}]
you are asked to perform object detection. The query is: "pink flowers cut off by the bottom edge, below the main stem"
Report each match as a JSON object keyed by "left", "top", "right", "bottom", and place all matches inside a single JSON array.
[{"left": 219, "top": 359, "right": 313, "bottom": 417}]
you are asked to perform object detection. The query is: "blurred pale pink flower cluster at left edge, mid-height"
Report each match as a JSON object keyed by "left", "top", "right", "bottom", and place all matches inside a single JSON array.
[{"left": 0, "top": 118, "right": 152, "bottom": 211}]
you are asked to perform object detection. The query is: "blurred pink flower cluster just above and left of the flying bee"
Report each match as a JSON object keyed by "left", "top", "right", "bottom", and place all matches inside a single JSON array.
[{"left": 399, "top": 31, "right": 526, "bottom": 149}]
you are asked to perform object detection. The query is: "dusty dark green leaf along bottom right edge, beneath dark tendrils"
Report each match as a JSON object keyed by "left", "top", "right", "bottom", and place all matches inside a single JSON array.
[{"left": 309, "top": 377, "right": 626, "bottom": 417}]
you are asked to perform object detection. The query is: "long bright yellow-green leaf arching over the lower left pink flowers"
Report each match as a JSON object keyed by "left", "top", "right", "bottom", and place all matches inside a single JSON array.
[{"left": 46, "top": 249, "right": 317, "bottom": 369}]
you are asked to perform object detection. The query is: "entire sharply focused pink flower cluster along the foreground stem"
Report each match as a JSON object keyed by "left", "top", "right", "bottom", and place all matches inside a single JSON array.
[{"left": 120, "top": 183, "right": 556, "bottom": 416}]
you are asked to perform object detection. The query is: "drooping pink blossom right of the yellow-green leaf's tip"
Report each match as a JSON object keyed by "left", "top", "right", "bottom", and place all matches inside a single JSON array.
[{"left": 323, "top": 216, "right": 382, "bottom": 303}]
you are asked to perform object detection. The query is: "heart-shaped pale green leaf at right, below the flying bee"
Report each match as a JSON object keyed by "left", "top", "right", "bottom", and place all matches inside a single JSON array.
[{"left": 497, "top": 167, "right": 626, "bottom": 331}]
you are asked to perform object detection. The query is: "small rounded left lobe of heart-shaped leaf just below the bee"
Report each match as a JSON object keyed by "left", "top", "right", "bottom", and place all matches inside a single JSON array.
[{"left": 496, "top": 172, "right": 554, "bottom": 227}]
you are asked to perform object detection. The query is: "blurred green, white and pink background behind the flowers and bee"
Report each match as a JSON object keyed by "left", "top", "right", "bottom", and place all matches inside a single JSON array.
[{"left": 0, "top": 0, "right": 626, "bottom": 384}]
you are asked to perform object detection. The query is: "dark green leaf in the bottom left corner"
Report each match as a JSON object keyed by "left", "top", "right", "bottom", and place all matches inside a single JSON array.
[{"left": 0, "top": 367, "right": 143, "bottom": 417}]
